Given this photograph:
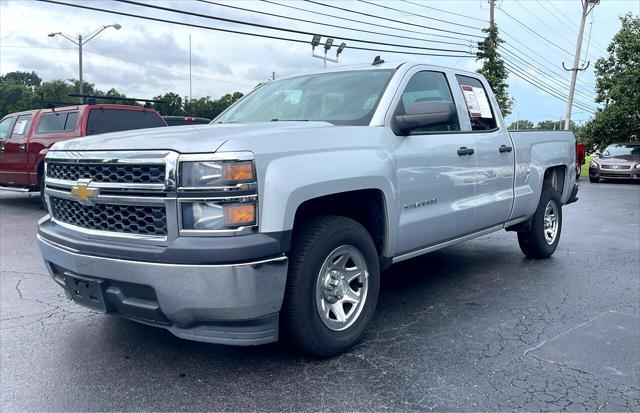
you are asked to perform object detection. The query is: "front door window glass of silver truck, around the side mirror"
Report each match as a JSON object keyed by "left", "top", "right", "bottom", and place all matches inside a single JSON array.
[{"left": 396, "top": 71, "right": 460, "bottom": 133}]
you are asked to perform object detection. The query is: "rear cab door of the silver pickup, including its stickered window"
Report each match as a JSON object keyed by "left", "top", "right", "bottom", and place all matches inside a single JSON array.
[{"left": 456, "top": 75, "right": 514, "bottom": 230}]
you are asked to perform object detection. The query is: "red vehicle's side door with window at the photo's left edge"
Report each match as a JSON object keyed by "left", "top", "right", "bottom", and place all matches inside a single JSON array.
[{"left": 0, "top": 113, "right": 33, "bottom": 185}]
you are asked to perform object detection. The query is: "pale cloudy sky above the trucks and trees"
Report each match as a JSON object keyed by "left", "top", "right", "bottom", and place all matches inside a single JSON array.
[{"left": 0, "top": 0, "right": 640, "bottom": 123}]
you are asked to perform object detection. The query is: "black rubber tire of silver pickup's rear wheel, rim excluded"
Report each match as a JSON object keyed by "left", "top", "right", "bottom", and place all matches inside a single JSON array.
[{"left": 518, "top": 186, "right": 562, "bottom": 259}]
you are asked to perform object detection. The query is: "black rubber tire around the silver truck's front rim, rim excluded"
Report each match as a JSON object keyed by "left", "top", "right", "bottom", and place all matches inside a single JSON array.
[{"left": 280, "top": 216, "right": 380, "bottom": 357}]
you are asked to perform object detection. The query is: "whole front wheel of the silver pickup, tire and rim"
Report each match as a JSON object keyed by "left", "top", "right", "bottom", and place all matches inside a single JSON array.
[{"left": 281, "top": 216, "right": 380, "bottom": 357}]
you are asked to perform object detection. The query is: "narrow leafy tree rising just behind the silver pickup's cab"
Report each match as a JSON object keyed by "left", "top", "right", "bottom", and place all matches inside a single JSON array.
[{"left": 478, "top": 24, "right": 513, "bottom": 117}]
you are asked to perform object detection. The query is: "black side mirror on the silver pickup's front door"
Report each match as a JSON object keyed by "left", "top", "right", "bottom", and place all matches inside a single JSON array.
[{"left": 395, "top": 101, "right": 456, "bottom": 135}]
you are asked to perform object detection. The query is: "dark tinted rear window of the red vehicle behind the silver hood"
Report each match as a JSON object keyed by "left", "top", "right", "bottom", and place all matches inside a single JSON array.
[{"left": 87, "top": 108, "right": 166, "bottom": 135}]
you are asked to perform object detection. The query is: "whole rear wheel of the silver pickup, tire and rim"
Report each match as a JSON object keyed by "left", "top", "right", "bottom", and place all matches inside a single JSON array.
[{"left": 518, "top": 186, "right": 562, "bottom": 258}]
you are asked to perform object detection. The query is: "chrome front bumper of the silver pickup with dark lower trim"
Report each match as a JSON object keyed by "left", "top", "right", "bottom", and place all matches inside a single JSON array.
[{"left": 38, "top": 235, "right": 288, "bottom": 345}]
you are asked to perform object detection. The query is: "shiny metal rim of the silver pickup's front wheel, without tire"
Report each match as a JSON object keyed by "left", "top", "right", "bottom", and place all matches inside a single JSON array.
[{"left": 316, "top": 245, "right": 369, "bottom": 331}]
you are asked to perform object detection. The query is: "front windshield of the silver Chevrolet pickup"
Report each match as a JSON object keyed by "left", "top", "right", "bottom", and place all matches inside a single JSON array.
[{"left": 216, "top": 69, "right": 393, "bottom": 125}]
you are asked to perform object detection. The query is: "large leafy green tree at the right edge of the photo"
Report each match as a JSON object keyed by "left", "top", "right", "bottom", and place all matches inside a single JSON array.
[{"left": 579, "top": 13, "right": 640, "bottom": 149}]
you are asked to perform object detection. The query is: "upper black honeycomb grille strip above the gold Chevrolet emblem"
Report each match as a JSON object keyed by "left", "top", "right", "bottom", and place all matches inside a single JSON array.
[{"left": 47, "top": 162, "right": 166, "bottom": 184}]
